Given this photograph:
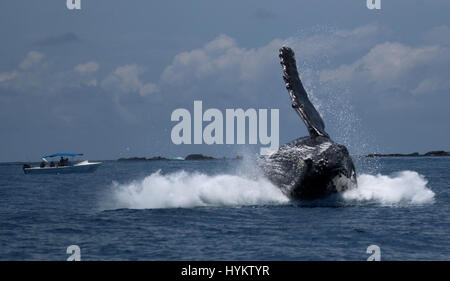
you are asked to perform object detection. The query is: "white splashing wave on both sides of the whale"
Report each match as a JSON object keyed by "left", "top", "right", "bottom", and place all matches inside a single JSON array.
[{"left": 103, "top": 171, "right": 435, "bottom": 209}]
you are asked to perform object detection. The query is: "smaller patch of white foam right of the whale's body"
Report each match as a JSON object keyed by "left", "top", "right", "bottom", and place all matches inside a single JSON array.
[{"left": 342, "top": 171, "right": 435, "bottom": 205}]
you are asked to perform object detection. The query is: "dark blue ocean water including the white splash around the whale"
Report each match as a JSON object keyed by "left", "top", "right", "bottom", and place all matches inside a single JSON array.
[{"left": 0, "top": 157, "right": 450, "bottom": 260}]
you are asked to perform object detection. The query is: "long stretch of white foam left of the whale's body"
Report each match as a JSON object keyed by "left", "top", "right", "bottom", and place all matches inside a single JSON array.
[{"left": 105, "top": 168, "right": 289, "bottom": 209}]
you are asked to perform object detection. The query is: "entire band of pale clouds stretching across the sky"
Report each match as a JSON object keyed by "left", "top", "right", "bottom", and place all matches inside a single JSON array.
[{"left": 0, "top": 24, "right": 450, "bottom": 114}]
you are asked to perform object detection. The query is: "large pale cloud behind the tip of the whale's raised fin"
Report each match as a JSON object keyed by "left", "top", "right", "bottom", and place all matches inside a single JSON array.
[{"left": 159, "top": 25, "right": 381, "bottom": 97}]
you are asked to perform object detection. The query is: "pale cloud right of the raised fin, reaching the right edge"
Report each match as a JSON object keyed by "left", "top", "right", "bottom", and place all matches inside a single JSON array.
[{"left": 320, "top": 42, "right": 450, "bottom": 95}]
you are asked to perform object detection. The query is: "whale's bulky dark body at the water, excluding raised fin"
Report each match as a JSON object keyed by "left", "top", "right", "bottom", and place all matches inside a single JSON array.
[{"left": 260, "top": 137, "right": 356, "bottom": 200}]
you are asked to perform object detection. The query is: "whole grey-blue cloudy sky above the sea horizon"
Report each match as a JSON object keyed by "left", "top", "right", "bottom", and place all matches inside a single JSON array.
[{"left": 0, "top": 0, "right": 450, "bottom": 162}]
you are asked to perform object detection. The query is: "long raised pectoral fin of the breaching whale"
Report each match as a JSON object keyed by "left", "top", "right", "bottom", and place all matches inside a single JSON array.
[{"left": 279, "top": 47, "right": 328, "bottom": 137}]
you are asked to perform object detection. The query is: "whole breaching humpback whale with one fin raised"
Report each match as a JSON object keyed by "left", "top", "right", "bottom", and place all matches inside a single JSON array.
[{"left": 260, "top": 46, "right": 356, "bottom": 200}]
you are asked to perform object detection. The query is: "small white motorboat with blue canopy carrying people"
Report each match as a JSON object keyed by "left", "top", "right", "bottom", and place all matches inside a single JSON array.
[{"left": 23, "top": 153, "right": 102, "bottom": 174}]
